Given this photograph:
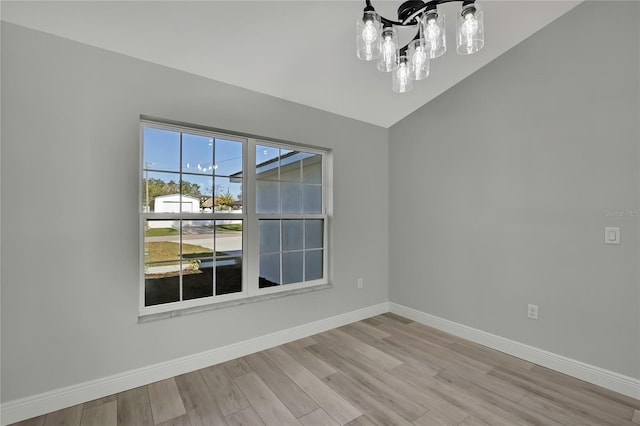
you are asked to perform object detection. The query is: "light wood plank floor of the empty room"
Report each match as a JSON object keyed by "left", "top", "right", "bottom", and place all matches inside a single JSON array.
[{"left": 11, "top": 314, "right": 640, "bottom": 426}]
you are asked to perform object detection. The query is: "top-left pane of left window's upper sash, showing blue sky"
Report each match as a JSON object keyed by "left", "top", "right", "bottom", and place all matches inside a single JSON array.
[{"left": 142, "top": 127, "right": 180, "bottom": 172}]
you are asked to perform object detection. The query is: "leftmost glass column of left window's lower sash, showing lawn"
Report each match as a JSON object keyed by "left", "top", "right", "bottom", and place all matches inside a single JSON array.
[{"left": 144, "top": 220, "right": 181, "bottom": 306}]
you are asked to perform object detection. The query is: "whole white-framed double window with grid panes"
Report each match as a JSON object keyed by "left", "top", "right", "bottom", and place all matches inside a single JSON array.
[{"left": 140, "top": 120, "right": 328, "bottom": 315}]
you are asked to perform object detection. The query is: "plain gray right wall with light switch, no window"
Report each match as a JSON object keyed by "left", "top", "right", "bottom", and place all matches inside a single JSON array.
[{"left": 389, "top": 1, "right": 640, "bottom": 378}]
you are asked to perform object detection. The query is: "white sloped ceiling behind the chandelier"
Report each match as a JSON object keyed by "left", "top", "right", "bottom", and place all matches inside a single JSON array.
[{"left": 0, "top": 0, "right": 581, "bottom": 127}]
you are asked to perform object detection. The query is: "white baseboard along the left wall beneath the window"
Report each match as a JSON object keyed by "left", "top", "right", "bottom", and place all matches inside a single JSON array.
[{"left": 0, "top": 302, "right": 389, "bottom": 426}]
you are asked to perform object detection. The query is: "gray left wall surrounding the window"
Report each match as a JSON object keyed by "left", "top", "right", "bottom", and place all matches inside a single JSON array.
[{"left": 1, "top": 23, "right": 388, "bottom": 401}]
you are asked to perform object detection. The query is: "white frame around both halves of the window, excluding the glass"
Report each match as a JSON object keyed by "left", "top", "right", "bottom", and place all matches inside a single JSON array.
[{"left": 138, "top": 118, "right": 331, "bottom": 319}]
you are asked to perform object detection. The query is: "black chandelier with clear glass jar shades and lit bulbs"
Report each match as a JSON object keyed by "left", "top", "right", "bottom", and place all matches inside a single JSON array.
[{"left": 356, "top": 0, "right": 484, "bottom": 93}]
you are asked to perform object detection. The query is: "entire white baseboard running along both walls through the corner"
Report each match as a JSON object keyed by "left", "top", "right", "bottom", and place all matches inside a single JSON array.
[{"left": 0, "top": 302, "right": 640, "bottom": 426}]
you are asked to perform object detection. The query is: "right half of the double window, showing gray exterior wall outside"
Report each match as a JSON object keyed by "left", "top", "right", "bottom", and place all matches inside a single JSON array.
[{"left": 256, "top": 144, "right": 324, "bottom": 288}]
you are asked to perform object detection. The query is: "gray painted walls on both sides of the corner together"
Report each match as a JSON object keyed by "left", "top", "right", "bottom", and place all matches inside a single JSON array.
[{"left": 1, "top": 2, "right": 640, "bottom": 401}]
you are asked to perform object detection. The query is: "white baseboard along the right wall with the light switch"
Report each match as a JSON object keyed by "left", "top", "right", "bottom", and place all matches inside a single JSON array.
[{"left": 389, "top": 302, "right": 640, "bottom": 399}]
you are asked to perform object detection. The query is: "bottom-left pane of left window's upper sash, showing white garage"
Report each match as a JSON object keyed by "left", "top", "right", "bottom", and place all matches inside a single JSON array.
[{"left": 142, "top": 171, "right": 180, "bottom": 213}]
